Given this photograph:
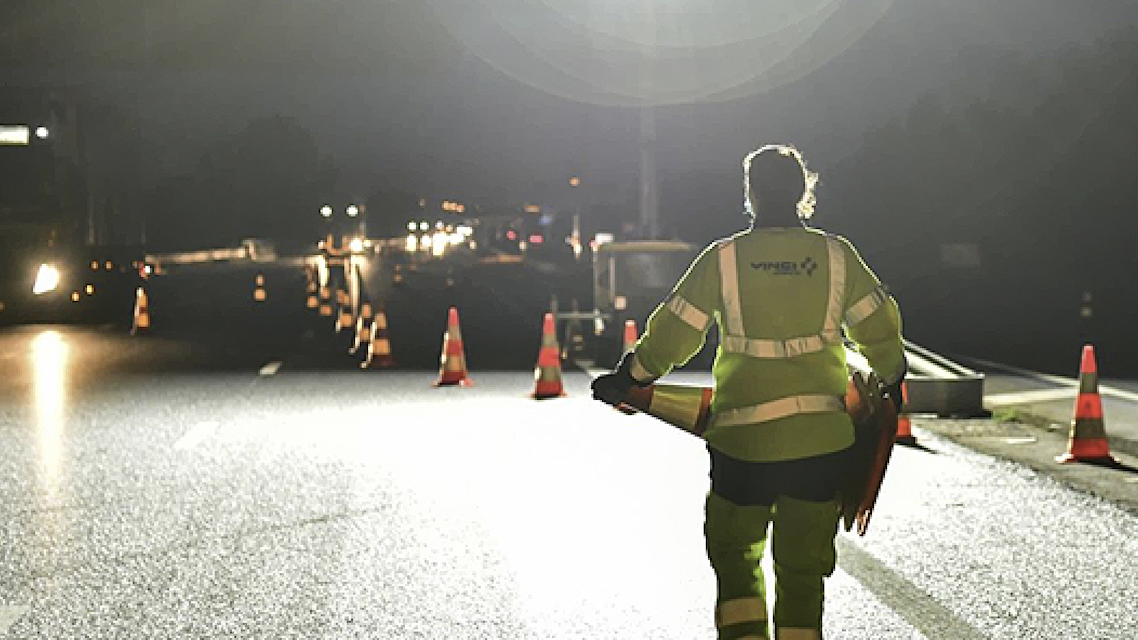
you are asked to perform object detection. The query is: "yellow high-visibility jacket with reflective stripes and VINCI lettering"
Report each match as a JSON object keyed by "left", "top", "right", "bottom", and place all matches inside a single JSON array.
[{"left": 630, "top": 228, "right": 905, "bottom": 462}]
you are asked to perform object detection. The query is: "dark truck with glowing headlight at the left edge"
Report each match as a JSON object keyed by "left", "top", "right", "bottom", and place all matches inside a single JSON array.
[{"left": 0, "top": 105, "right": 148, "bottom": 325}]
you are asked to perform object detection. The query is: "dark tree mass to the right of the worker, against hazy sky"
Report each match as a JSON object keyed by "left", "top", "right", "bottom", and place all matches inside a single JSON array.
[{"left": 826, "top": 28, "right": 1138, "bottom": 372}]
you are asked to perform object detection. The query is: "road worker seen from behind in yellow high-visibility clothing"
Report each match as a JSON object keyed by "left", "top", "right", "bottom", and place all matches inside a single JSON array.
[{"left": 593, "top": 145, "right": 906, "bottom": 640}]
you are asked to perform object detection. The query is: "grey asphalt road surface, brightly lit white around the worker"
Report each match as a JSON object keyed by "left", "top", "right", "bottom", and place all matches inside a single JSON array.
[{"left": 0, "top": 257, "right": 1138, "bottom": 639}]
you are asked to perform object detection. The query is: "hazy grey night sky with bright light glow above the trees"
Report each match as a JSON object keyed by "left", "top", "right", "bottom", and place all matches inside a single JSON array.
[{"left": 0, "top": 0, "right": 1138, "bottom": 206}]
